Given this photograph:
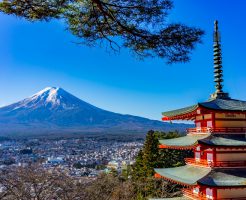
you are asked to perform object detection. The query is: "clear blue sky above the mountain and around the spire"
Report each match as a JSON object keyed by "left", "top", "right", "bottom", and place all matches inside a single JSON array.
[{"left": 0, "top": 0, "right": 246, "bottom": 119}]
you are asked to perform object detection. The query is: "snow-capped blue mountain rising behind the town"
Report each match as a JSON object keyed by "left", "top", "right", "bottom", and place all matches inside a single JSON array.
[{"left": 0, "top": 87, "right": 189, "bottom": 135}]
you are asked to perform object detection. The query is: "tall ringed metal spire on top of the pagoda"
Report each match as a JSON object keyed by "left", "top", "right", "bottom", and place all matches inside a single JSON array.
[{"left": 211, "top": 20, "right": 229, "bottom": 99}]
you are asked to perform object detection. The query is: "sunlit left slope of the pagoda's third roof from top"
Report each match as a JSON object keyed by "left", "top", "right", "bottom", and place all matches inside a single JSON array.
[{"left": 155, "top": 165, "right": 211, "bottom": 185}]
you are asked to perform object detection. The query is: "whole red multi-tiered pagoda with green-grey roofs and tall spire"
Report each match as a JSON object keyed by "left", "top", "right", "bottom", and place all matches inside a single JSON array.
[{"left": 155, "top": 21, "right": 246, "bottom": 200}]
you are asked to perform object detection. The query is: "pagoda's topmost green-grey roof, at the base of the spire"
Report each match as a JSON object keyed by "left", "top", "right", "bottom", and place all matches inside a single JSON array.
[{"left": 162, "top": 98, "right": 246, "bottom": 118}]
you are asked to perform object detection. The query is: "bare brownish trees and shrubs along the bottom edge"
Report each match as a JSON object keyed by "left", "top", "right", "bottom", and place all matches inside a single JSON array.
[{"left": 0, "top": 167, "right": 181, "bottom": 200}]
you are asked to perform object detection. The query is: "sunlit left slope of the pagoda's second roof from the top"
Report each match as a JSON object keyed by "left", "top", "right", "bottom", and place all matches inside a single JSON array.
[{"left": 159, "top": 134, "right": 210, "bottom": 148}]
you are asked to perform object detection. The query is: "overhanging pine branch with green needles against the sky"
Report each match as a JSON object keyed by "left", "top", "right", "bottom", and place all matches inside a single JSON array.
[{"left": 0, "top": 0, "right": 203, "bottom": 63}]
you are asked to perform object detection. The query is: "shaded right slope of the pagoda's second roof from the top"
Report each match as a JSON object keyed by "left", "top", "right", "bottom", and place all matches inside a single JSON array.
[{"left": 198, "top": 134, "right": 246, "bottom": 147}]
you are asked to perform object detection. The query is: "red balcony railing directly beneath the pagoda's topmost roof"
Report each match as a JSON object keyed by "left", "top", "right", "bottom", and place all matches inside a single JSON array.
[{"left": 186, "top": 127, "right": 246, "bottom": 133}]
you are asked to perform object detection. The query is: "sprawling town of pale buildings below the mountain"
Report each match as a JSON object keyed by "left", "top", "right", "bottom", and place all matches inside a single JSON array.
[{"left": 0, "top": 136, "right": 143, "bottom": 178}]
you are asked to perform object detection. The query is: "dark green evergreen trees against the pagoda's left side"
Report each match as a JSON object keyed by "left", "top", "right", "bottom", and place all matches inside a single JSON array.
[{"left": 133, "top": 131, "right": 183, "bottom": 199}]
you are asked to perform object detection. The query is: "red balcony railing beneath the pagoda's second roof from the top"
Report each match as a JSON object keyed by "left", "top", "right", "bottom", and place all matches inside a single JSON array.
[{"left": 185, "top": 158, "right": 246, "bottom": 167}]
